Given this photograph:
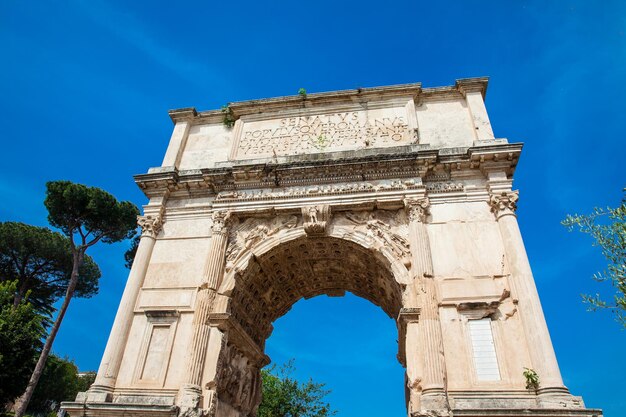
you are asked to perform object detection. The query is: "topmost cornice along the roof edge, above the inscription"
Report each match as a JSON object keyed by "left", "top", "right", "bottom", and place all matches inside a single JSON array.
[{"left": 169, "top": 77, "right": 488, "bottom": 124}]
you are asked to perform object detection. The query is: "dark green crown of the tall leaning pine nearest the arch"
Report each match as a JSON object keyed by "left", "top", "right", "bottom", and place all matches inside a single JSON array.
[{"left": 44, "top": 181, "right": 139, "bottom": 246}]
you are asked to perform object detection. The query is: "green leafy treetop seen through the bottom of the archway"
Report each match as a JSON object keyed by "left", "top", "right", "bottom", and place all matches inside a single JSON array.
[{"left": 258, "top": 360, "right": 337, "bottom": 417}]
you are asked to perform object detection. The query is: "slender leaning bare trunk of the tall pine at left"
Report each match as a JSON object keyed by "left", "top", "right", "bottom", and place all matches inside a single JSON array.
[{"left": 15, "top": 247, "right": 86, "bottom": 417}]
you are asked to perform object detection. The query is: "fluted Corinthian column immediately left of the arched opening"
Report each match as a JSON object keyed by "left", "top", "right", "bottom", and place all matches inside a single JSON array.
[{"left": 180, "top": 211, "right": 230, "bottom": 416}]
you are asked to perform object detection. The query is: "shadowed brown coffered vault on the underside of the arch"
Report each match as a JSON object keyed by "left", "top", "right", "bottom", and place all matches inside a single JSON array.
[{"left": 218, "top": 234, "right": 404, "bottom": 410}]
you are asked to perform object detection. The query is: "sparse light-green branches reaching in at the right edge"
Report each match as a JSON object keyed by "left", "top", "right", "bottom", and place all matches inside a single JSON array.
[{"left": 561, "top": 191, "right": 626, "bottom": 328}]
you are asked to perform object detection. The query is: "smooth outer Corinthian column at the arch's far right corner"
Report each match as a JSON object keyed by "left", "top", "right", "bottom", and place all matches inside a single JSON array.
[{"left": 489, "top": 191, "right": 568, "bottom": 395}]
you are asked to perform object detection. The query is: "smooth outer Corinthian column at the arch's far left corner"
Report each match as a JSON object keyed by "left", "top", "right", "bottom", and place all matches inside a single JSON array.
[{"left": 87, "top": 212, "right": 163, "bottom": 401}]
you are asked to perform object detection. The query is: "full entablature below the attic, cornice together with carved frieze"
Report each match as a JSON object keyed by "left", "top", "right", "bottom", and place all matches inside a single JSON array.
[{"left": 135, "top": 140, "right": 522, "bottom": 201}]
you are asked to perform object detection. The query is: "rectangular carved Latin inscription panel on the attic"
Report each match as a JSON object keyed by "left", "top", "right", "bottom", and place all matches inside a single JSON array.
[{"left": 235, "top": 107, "right": 416, "bottom": 159}]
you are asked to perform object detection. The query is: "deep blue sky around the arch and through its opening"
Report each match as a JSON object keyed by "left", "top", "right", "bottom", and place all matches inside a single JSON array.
[{"left": 0, "top": 0, "right": 626, "bottom": 417}]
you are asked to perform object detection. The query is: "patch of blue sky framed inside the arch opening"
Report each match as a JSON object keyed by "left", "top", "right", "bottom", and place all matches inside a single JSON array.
[{"left": 265, "top": 292, "right": 406, "bottom": 417}]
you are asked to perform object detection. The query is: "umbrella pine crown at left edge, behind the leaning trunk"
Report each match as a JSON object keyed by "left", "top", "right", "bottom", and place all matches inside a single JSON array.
[{"left": 0, "top": 222, "right": 101, "bottom": 316}]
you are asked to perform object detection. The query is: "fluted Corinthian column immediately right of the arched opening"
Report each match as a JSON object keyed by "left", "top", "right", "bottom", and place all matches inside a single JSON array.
[{"left": 404, "top": 197, "right": 449, "bottom": 411}]
